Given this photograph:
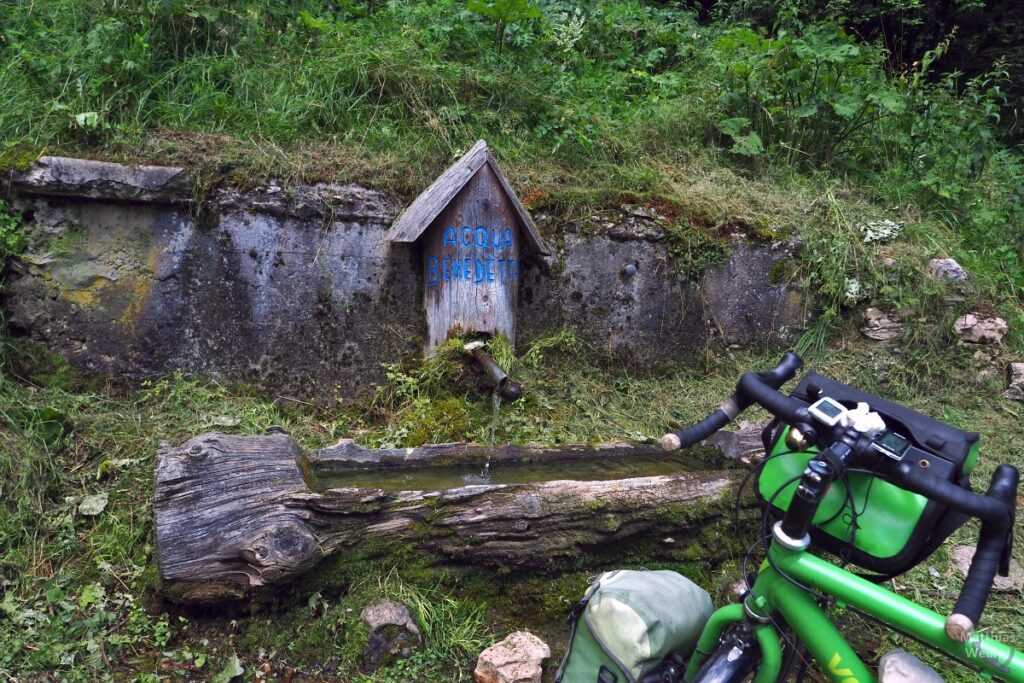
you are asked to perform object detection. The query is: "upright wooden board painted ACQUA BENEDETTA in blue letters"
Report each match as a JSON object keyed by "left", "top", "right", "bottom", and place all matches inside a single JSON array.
[{"left": 423, "top": 165, "right": 522, "bottom": 352}]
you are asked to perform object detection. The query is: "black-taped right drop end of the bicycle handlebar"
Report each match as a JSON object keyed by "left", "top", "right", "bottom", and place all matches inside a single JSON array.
[{"left": 946, "top": 465, "right": 1020, "bottom": 640}]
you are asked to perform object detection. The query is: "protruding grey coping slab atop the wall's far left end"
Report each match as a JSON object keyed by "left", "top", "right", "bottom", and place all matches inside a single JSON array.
[{"left": 0, "top": 157, "right": 193, "bottom": 204}]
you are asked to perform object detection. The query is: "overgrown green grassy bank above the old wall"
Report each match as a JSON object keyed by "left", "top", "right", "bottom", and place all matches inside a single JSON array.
[{"left": 0, "top": 0, "right": 1020, "bottom": 313}]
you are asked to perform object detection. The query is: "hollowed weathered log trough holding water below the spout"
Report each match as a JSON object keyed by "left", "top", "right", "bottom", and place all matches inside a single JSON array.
[{"left": 154, "top": 433, "right": 738, "bottom": 603}]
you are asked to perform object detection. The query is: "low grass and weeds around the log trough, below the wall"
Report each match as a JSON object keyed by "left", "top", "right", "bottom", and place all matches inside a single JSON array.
[{"left": 0, "top": 327, "right": 1024, "bottom": 681}]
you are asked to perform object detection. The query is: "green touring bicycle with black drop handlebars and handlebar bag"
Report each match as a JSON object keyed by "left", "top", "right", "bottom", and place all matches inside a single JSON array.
[{"left": 645, "top": 353, "right": 1024, "bottom": 683}]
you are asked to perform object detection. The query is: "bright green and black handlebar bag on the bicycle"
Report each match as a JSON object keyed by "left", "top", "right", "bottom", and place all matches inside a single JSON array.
[{"left": 755, "top": 372, "right": 980, "bottom": 577}]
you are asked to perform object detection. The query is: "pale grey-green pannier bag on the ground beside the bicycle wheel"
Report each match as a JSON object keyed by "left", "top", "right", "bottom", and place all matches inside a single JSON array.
[{"left": 555, "top": 569, "right": 712, "bottom": 683}]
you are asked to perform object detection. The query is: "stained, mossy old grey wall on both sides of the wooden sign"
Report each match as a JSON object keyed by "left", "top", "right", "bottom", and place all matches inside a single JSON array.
[{"left": 0, "top": 158, "right": 801, "bottom": 401}]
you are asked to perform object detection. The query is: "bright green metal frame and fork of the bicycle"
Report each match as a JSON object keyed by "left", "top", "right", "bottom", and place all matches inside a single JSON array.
[{"left": 685, "top": 543, "right": 1024, "bottom": 683}]
